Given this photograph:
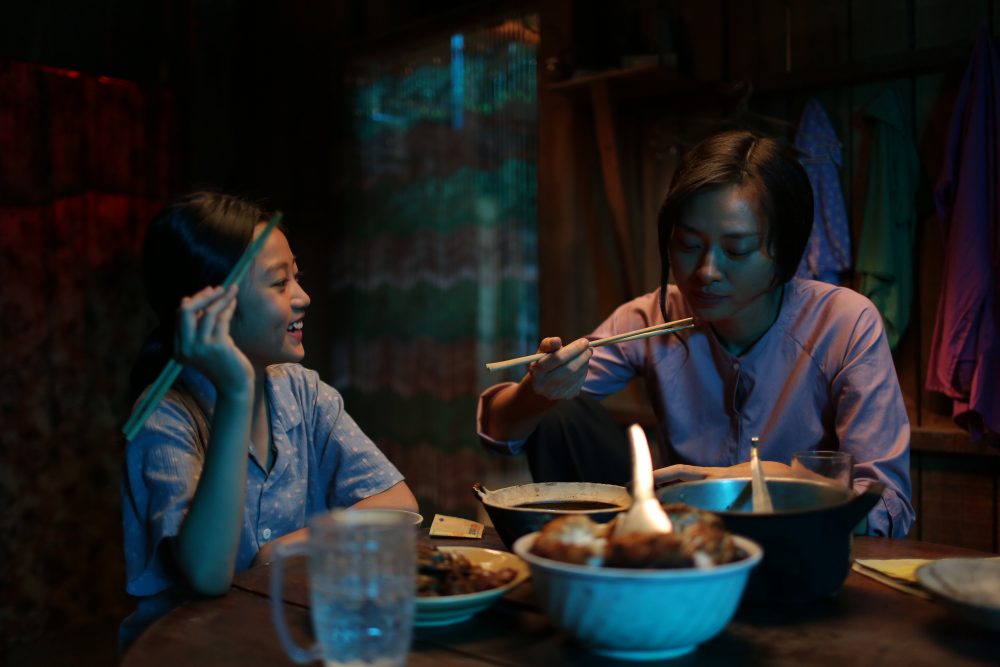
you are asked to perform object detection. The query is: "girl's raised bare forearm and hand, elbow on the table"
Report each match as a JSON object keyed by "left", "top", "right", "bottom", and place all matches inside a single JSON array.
[{"left": 175, "top": 286, "right": 254, "bottom": 595}]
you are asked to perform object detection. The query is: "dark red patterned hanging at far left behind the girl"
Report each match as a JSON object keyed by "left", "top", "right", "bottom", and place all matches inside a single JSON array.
[{"left": 0, "top": 61, "right": 176, "bottom": 648}]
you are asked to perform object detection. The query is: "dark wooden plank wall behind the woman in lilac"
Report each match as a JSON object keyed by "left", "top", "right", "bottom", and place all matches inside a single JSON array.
[{"left": 539, "top": 0, "right": 1000, "bottom": 551}]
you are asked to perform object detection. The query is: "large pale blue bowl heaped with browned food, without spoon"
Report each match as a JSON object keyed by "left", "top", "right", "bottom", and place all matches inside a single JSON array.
[{"left": 514, "top": 504, "right": 762, "bottom": 659}]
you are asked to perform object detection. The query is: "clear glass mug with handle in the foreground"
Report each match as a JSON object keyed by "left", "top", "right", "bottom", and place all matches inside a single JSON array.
[{"left": 271, "top": 510, "right": 417, "bottom": 667}]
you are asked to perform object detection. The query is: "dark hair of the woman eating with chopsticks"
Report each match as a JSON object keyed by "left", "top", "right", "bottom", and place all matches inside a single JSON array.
[{"left": 657, "top": 130, "right": 813, "bottom": 320}]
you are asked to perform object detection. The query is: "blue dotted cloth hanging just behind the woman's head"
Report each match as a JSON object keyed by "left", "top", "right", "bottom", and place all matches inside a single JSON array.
[{"left": 795, "top": 99, "right": 851, "bottom": 285}]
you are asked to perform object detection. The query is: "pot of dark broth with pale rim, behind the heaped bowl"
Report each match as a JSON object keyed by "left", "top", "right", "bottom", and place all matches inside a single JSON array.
[{"left": 472, "top": 482, "right": 632, "bottom": 549}]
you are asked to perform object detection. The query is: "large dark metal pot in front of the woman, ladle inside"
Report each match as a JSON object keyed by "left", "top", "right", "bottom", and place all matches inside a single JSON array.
[{"left": 657, "top": 477, "right": 884, "bottom": 603}]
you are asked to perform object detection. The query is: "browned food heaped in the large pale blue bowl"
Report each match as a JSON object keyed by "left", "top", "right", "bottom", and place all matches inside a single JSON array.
[{"left": 531, "top": 503, "right": 742, "bottom": 569}]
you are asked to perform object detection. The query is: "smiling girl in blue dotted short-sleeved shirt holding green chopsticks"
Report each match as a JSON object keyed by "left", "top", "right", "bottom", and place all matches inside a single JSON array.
[{"left": 121, "top": 192, "right": 417, "bottom": 645}]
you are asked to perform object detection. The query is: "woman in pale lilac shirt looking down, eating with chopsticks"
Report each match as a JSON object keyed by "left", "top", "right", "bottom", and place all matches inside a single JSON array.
[{"left": 479, "top": 130, "right": 914, "bottom": 537}]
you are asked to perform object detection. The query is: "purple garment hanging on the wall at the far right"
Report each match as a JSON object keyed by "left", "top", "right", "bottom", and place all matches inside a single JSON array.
[{"left": 926, "top": 28, "right": 1000, "bottom": 436}]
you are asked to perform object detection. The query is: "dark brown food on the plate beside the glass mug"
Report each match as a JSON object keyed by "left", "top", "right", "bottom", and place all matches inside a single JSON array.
[{"left": 417, "top": 542, "right": 517, "bottom": 597}]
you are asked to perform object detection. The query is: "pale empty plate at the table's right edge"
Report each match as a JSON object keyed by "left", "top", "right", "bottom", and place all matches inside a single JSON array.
[{"left": 917, "top": 558, "right": 1000, "bottom": 631}]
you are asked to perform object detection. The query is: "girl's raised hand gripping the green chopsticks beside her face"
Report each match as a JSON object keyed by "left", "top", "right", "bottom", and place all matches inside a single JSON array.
[{"left": 174, "top": 285, "right": 254, "bottom": 389}]
